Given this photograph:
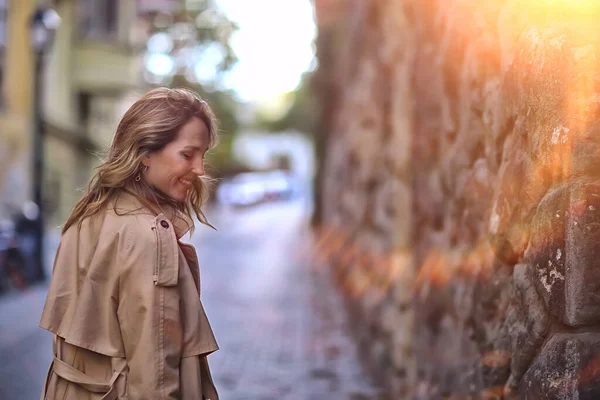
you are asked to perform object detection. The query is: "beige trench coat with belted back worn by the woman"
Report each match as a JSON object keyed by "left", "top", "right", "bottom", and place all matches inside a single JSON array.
[{"left": 40, "top": 192, "right": 218, "bottom": 400}]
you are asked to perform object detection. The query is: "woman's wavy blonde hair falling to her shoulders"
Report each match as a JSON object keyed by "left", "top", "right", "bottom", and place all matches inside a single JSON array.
[{"left": 62, "top": 88, "right": 218, "bottom": 233}]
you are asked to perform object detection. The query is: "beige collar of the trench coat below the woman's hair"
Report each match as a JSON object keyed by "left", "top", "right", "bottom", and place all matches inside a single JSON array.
[{"left": 112, "top": 189, "right": 194, "bottom": 240}]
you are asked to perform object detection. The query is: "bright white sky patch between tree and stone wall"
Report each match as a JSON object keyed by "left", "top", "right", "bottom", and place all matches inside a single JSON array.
[{"left": 217, "top": 0, "right": 316, "bottom": 103}]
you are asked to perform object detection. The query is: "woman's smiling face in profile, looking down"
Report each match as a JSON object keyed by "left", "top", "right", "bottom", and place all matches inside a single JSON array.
[{"left": 143, "top": 117, "right": 209, "bottom": 201}]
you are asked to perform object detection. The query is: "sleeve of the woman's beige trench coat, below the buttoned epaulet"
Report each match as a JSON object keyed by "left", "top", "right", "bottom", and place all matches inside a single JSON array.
[{"left": 118, "top": 220, "right": 183, "bottom": 400}]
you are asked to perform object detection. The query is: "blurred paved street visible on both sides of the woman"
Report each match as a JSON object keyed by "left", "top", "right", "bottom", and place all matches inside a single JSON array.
[{"left": 0, "top": 200, "right": 378, "bottom": 400}]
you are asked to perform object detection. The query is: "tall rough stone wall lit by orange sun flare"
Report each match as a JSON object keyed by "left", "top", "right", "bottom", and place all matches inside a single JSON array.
[{"left": 320, "top": 0, "right": 600, "bottom": 399}]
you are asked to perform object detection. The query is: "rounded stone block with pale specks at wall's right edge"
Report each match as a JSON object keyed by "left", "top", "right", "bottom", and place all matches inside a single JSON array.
[{"left": 525, "top": 181, "right": 600, "bottom": 326}]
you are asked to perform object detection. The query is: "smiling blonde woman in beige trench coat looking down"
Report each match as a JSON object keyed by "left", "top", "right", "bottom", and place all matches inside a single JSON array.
[{"left": 40, "top": 88, "right": 218, "bottom": 400}]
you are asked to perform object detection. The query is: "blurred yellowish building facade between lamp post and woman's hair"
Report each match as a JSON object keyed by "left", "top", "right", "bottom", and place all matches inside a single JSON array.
[{"left": 43, "top": 0, "right": 140, "bottom": 225}]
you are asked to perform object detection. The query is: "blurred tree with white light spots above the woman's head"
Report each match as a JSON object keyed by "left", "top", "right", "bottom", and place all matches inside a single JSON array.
[{"left": 139, "top": 0, "right": 239, "bottom": 177}]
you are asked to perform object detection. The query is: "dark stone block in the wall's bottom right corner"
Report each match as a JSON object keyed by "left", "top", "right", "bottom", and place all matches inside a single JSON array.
[{"left": 519, "top": 333, "right": 600, "bottom": 400}]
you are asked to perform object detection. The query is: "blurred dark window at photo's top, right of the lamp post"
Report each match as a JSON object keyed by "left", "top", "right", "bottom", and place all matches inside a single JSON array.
[{"left": 78, "top": 0, "right": 119, "bottom": 39}]
